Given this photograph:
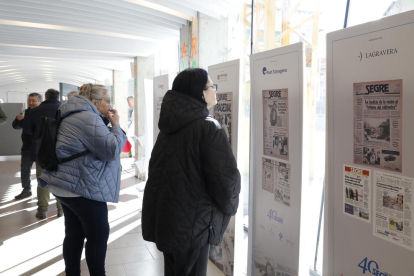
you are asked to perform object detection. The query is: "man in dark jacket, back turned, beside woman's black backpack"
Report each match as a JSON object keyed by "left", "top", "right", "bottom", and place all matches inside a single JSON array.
[{"left": 23, "top": 89, "right": 63, "bottom": 219}]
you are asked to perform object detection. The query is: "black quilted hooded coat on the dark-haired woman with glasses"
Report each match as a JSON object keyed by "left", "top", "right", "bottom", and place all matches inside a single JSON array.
[{"left": 142, "top": 91, "right": 240, "bottom": 253}]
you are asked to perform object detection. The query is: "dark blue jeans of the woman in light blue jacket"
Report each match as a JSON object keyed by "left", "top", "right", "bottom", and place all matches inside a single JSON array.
[{"left": 56, "top": 196, "right": 109, "bottom": 276}]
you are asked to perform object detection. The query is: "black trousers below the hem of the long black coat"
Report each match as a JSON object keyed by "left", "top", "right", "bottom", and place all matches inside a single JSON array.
[{"left": 164, "top": 243, "right": 210, "bottom": 276}]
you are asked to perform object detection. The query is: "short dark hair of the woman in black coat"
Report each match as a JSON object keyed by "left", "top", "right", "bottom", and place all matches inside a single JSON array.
[{"left": 172, "top": 68, "right": 208, "bottom": 105}]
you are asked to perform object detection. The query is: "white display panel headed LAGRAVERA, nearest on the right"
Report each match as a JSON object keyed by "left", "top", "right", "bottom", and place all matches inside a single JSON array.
[{"left": 323, "top": 9, "right": 414, "bottom": 276}]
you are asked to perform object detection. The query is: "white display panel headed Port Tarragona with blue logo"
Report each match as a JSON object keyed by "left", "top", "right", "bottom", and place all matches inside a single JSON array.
[{"left": 248, "top": 43, "right": 304, "bottom": 276}]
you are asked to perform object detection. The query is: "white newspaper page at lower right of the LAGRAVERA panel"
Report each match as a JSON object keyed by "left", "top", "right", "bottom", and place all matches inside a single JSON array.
[{"left": 373, "top": 171, "right": 414, "bottom": 251}]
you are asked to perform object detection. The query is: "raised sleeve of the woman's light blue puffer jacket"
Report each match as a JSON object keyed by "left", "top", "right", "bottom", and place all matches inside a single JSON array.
[{"left": 82, "top": 116, "right": 127, "bottom": 161}]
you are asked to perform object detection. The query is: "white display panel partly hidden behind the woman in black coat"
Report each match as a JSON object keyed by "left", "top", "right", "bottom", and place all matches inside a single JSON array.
[{"left": 208, "top": 60, "right": 241, "bottom": 276}]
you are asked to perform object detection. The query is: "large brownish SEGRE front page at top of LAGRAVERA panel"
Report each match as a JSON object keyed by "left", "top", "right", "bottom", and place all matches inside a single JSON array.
[{"left": 354, "top": 80, "right": 402, "bottom": 172}]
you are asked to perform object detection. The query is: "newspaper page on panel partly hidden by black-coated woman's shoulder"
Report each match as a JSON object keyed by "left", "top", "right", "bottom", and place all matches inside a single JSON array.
[{"left": 213, "top": 92, "right": 233, "bottom": 145}]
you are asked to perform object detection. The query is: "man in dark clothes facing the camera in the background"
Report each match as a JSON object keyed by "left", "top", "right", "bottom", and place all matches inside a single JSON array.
[{"left": 12, "top": 93, "right": 42, "bottom": 200}]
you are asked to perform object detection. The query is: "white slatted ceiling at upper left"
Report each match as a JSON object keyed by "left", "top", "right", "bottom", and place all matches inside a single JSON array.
[{"left": 0, "top": 0, "right": 239, "bottom": 86}]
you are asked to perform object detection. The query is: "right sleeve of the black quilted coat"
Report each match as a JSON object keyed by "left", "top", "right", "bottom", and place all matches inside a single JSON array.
[{"left": 202, "top": 129, "right": 240, "bottom": 216}]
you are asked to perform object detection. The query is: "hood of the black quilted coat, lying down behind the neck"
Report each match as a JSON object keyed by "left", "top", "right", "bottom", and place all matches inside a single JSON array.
[{"left": 158, "top": 90, "right": 209, "bottom": 134}]
